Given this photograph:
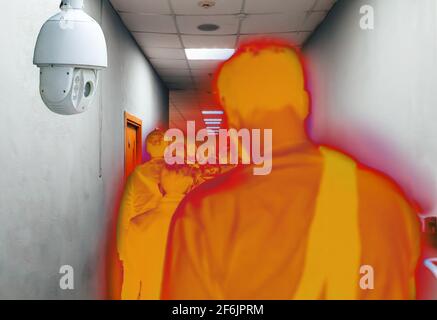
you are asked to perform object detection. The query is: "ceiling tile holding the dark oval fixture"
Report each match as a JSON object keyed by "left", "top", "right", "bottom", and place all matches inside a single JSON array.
[{"left": 176, "top": 16, "right": 239, "bottom": 35}]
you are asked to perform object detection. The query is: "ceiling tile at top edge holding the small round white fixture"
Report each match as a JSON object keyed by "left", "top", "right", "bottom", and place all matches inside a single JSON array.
[{"left": 171, "top": 0, "right": 243, "bottom": 15}]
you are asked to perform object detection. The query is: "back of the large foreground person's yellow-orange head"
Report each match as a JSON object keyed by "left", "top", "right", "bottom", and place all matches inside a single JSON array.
[{"left": 216, "top": 40, "right": 309, "bottom": 128}]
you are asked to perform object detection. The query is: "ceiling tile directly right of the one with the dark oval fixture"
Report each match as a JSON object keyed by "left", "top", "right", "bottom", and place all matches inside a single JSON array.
[{"left": 241, "top": 12, "right": 305, "bottom": 34}]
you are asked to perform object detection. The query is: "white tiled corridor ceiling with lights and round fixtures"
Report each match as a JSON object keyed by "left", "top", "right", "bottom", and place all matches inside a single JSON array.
[{"left": 111, "top": 0, "right": 336, "bottom": 126}]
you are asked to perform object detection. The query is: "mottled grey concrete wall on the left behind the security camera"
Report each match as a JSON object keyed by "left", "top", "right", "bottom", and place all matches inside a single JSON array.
[{"left": 0, "top": 0, "right": 168, "bottom": 299}]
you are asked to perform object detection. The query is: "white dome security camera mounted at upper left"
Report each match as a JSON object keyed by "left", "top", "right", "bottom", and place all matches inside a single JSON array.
[{"left": 33, "top": 0, "right": 108, "bottom": 115}]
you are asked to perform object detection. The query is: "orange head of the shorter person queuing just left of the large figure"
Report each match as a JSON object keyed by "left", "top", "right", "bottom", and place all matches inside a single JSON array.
[{"left": 161, "top": 165, "right": 194, "bottom": 195}]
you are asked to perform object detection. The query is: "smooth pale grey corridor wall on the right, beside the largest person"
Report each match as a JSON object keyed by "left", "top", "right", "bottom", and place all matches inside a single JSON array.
[{"left": 305, "top": 0, "right": 437, "bottom": 213}]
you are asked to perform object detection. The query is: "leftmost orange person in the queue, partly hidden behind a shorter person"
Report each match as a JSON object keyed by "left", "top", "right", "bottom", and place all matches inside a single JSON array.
[{"left": 117, "top": 129, "right": 167, "bottom": 297}]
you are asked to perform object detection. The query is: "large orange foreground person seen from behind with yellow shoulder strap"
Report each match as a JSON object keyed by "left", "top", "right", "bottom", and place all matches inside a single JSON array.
[{"left": 161, "top": 40, "right": 420, "bottom": 300}]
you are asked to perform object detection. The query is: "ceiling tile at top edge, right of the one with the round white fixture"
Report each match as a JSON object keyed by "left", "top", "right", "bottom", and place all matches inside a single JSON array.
[{"left": 245, "top": 0, "right": 316, "bottom": 13}]
